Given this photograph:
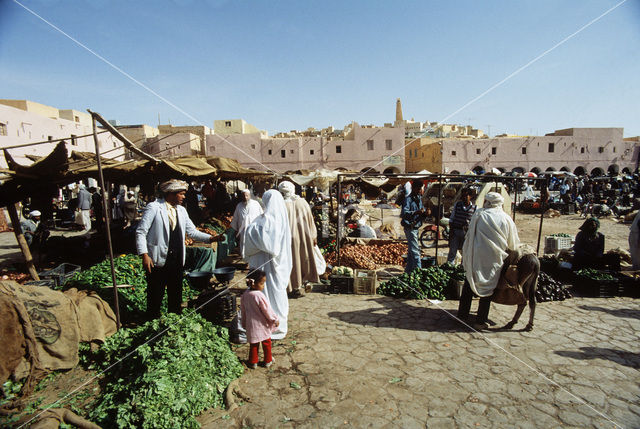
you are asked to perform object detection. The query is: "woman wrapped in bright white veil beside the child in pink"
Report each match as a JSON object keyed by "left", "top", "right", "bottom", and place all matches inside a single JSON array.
[{"left": 243, "top": 189, "right": 292, "bottom": 340}]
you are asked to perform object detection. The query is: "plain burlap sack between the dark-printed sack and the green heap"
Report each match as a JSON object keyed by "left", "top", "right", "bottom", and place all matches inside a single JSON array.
[{"left": 64, "top": 288, "right": 118, "bottom": 342}]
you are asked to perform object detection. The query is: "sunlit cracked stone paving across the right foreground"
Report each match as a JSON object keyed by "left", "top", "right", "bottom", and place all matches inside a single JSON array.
[{"left": 200, "top": 293, "right": 640, "bottom": 428}]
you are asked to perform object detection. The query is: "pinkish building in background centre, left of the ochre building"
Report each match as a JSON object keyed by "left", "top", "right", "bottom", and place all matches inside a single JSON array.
[{"left": 206, "top": 123, "right": 405, "bottom": 173}]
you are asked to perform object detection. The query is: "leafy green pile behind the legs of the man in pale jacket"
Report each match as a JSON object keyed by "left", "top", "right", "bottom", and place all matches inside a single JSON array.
[{"left": 64, "top": 255, "right": 199, "bottom": 314}]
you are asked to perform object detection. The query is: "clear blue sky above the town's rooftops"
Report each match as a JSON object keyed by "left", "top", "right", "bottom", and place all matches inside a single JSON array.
[{"left": 0, "top": 0, "right": 640, "bottom": 136}]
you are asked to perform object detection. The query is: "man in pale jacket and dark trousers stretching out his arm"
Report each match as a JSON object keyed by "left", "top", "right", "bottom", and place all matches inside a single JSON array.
[{"left": 136, "top": 179, "right": 224, "bottom": 318}]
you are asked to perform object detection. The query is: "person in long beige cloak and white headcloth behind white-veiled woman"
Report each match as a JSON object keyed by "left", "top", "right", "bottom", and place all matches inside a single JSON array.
[{"left": 278, "top": 181, "right": 324, "bottom": 296}]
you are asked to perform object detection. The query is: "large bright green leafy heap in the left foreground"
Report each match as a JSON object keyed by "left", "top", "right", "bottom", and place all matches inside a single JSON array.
[{"left": 88, "top": 313, "right": 243, "bottom": 428}]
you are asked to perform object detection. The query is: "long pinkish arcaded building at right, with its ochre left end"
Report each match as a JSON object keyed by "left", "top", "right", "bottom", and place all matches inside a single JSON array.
[{"left": 405, "top": 128, "right": 640, "bottom": 176}]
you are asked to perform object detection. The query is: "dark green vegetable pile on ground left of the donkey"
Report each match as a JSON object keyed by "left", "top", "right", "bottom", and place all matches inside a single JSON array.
[{"left": 377, "top": 267, "right": 451, "bottom": 301}]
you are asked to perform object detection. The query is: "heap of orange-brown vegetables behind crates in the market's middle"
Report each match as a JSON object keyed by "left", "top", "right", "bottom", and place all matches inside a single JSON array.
[{"left": 325, "top": 243, "right": 407, "bottom": 270}]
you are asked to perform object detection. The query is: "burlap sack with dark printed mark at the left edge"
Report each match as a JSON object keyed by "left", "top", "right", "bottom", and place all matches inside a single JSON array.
[{"left": 0, "top": 281, "right": 80, "bottom": 370}]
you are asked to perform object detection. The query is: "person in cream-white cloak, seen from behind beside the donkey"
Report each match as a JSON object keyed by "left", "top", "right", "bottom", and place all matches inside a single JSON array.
[{"left": 458, "top": 192, "right": 520, "bottom": 330}]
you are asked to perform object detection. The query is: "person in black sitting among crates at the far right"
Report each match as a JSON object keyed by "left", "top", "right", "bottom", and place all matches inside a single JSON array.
[{"left": 573, "top": 217, "right": 619, "bottom": 270}]
